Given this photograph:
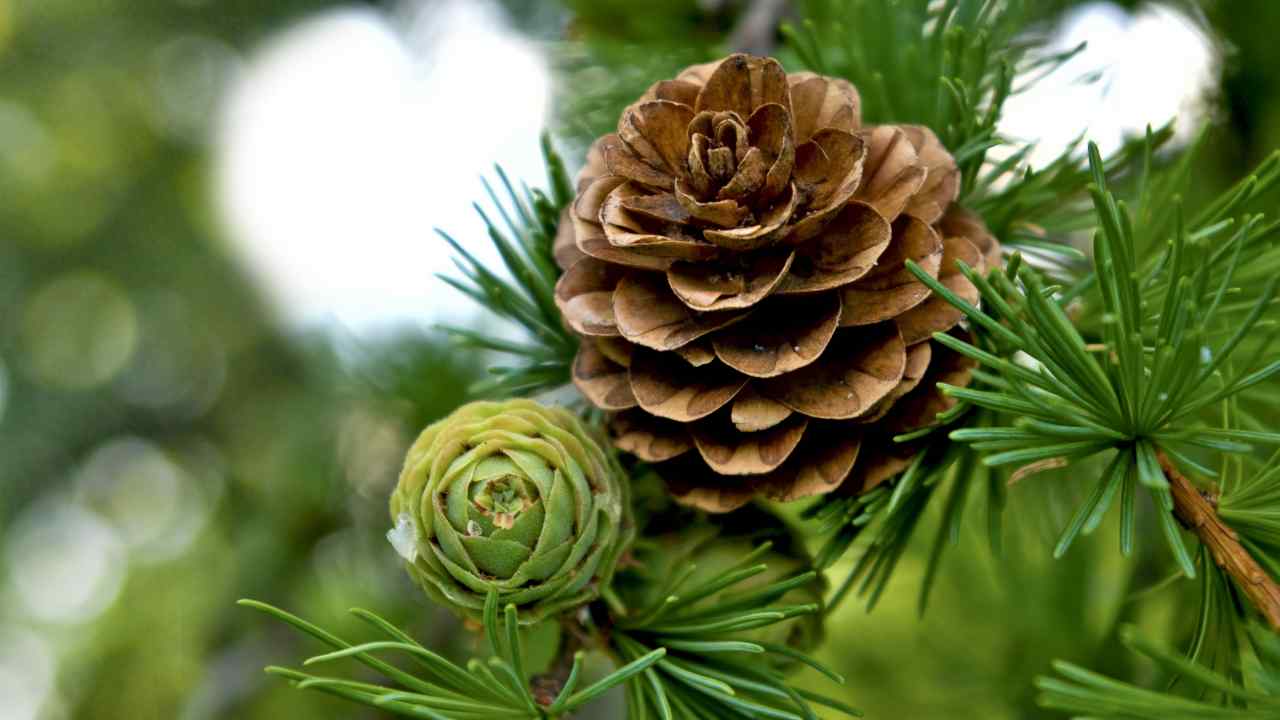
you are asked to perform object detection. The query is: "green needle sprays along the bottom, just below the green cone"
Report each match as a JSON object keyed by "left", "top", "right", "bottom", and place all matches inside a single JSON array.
[{"left": 241, "top": 527, "right": 860, "bottom": 720}]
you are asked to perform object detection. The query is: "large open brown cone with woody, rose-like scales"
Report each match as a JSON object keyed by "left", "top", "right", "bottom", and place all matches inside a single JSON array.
[{"left": 556, "top": 55, "right": 1000, "bottom": 511}]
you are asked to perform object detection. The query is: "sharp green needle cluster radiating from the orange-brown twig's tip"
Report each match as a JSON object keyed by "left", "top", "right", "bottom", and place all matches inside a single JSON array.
[{"left": 909, "top": 141, "right": 1280, "bottom": 577}]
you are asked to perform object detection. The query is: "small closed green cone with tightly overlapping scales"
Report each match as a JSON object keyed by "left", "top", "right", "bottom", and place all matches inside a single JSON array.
[{"left": 388, "top": 400, "right": 635, "bottom": 624}]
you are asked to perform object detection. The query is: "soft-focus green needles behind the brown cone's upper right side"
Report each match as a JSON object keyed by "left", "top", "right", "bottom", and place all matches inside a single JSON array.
[{"left": 783, "top": 0, "right": 1172, "bottom": 263}]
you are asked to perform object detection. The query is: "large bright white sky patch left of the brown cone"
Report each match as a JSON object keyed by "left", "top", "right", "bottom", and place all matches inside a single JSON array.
[{"left": 216, "top": 0, "right": 549, "bottom": 334}]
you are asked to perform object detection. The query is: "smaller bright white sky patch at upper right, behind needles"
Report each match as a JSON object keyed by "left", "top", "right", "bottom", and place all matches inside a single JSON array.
[{"left": 1001, "top": 3, "right": 1220, "bottom": 163}]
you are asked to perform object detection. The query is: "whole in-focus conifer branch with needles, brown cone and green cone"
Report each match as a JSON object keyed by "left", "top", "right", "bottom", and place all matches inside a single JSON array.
[{"left": 241, "top": 0, "right": 1280, "bottom": 720}]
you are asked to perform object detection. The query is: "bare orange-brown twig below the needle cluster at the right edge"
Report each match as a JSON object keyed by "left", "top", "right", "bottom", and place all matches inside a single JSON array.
[{"left": 1158, "top": 451, "right": 1280, "bottom": 632}]
